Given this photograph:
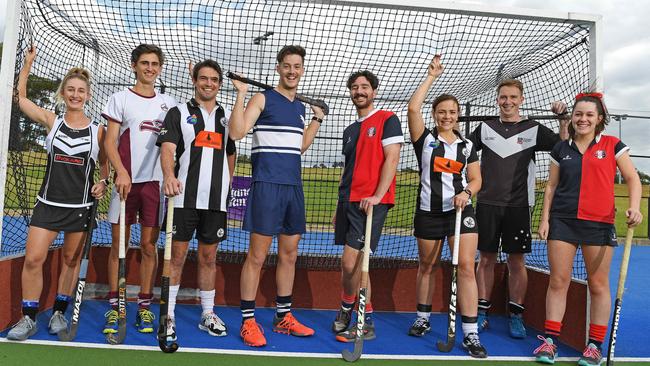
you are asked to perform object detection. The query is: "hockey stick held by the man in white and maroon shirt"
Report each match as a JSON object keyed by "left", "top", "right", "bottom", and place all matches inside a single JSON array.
[{"left": 106, "top": 200, "right": 126, "bottom": 344}]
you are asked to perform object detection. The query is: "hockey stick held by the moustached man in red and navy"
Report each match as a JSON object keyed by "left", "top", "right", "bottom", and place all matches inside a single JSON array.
[{"left": 342, "top": 206, "right": 372, "bottom": 362}]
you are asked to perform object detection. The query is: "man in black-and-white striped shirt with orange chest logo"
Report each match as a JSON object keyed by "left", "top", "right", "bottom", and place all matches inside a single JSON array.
[{"left": 157, "top": 60, "right": 235, "bottom": 338}]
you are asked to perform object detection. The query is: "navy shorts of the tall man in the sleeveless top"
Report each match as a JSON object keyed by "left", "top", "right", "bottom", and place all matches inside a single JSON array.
[{"left": 243, "top": 182, "right": 307, "bottom": 236}]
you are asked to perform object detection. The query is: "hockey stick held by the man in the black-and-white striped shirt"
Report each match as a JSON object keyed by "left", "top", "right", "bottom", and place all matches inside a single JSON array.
[{"left": 158, "top": 197, "right": 178, "bottom": 353}]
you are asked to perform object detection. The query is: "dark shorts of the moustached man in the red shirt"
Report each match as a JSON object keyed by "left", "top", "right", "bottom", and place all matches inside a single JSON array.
[{"left": 334, "top": 202, "right": 390, "bottom": 252}]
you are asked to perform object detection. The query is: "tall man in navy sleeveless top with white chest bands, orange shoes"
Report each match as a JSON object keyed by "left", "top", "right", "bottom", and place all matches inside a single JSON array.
[{"left": 230, "top": 45, "right": 325, "bottom": 347}]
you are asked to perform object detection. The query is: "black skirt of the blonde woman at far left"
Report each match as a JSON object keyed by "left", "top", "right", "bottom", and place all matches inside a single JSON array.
[{"left": 29, "top": 201, "right": 90, "bottom": 233}]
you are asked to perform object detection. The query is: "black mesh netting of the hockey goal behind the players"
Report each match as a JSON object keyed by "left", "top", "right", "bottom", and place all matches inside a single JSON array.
[{"left": 2, "top": 0, "right": 589, "bottom": 277}]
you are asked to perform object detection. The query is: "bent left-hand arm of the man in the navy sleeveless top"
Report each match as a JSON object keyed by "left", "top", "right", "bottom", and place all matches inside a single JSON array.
[{"left": 228, "top": 79, "right": 266, "bottom": 141}]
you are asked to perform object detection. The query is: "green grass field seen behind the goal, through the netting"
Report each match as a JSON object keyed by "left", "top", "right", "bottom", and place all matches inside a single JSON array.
[{"left": 5, "top": 152, "right": 650, "bottom": 238}]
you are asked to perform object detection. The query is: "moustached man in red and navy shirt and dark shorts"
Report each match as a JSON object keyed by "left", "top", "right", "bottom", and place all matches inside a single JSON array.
[{"left": 332, "top": 70, "right": 404, "bottom": 342}]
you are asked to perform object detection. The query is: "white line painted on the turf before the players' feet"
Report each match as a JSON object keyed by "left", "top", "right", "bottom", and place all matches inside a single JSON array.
[{"left": 0, "top": 338, "right": 650, "bottom": 362}]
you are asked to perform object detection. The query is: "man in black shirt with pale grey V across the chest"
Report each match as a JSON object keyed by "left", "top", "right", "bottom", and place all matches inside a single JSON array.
[{"left": 469, "top": 79, "right": 568, "bottom": 338}]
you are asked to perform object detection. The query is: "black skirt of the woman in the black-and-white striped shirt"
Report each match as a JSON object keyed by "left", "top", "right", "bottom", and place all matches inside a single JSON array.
[{"left": 413, "top": 205, "right": 478, "bottom": 240}]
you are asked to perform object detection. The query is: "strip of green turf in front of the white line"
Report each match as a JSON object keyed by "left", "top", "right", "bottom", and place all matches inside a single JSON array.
[{"left": 0, "top": 342, "right": 650, "bottom": 366}]
